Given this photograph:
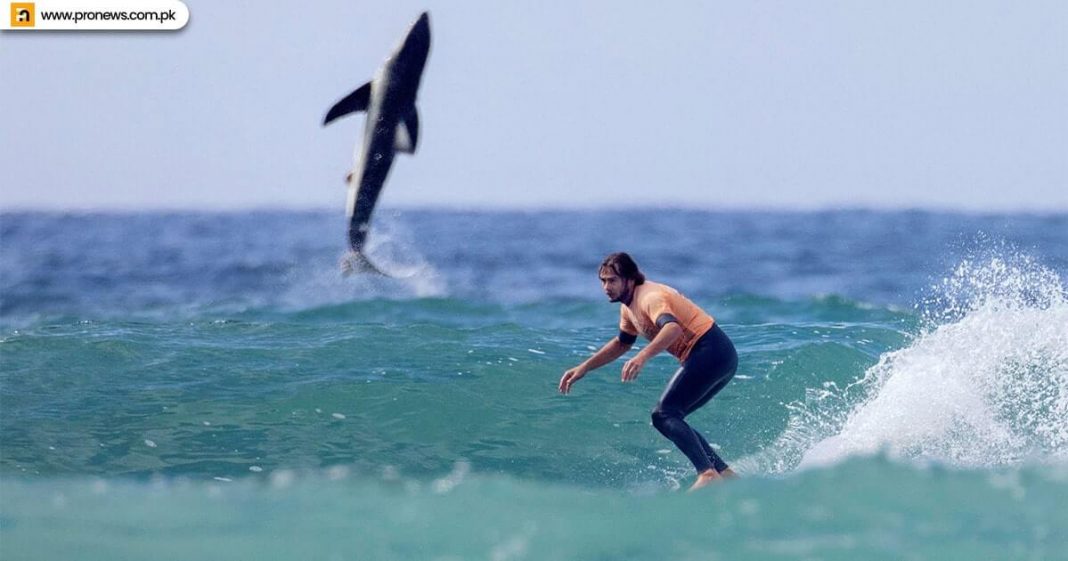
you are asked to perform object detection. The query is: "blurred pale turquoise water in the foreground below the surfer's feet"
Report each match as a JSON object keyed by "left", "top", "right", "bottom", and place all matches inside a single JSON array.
[{"left": 3, "top": 459, "right": 1068, "bottom": 560}]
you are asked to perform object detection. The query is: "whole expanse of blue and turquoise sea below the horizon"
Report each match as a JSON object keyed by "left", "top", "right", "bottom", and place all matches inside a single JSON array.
[{"left": 0, "top": 209, "right": 1068, "bottom": 561}]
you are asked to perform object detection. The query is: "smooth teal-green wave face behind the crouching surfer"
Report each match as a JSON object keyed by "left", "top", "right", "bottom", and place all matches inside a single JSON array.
[{"left": 0, "top": 290, "right": 910, "bottom": 487}]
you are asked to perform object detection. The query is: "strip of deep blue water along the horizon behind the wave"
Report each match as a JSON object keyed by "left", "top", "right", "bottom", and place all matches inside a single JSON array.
[{"left": 0, "top": 211, "right": 1068, "bottom": 322}]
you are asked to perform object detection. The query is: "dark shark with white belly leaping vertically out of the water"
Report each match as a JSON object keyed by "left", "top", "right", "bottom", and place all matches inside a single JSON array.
[{"left": 323, "top": 12, "right": 430, "bottom": 275}]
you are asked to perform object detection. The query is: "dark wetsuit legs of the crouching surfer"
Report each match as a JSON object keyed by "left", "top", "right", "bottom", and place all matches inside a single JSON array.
[{"left": 653, "top": 324, "right": 738, "bottom": 473}]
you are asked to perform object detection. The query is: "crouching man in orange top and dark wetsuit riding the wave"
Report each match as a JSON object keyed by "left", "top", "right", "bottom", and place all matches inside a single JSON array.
[{"left": 560, "top": 252, "right": 738, "bottom": 490}]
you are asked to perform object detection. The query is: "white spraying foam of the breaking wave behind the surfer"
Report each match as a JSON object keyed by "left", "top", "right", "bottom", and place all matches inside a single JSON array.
[{"left": 747, "top": 256, "right": 1068, "bottom": 471}]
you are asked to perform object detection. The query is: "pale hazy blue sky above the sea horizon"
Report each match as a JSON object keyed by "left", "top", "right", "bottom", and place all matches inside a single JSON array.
[{"left": 0, "top": 0, "right": 1068, "bottom": 212}]
